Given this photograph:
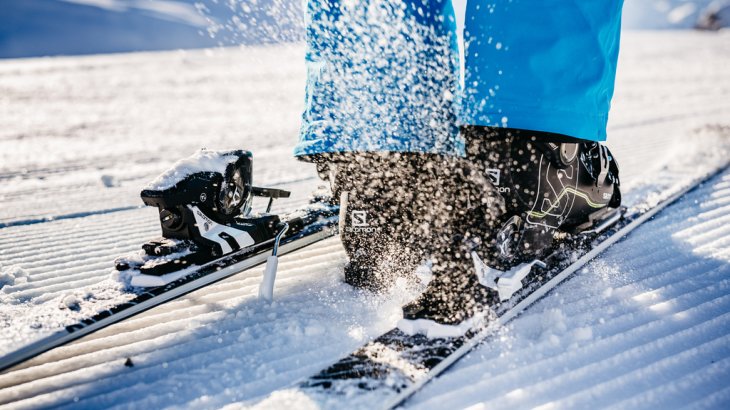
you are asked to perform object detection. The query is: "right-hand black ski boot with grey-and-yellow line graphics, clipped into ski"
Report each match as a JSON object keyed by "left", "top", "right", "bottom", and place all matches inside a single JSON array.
[{"left": 399, "top": 127, "right": 621, "bottom": 336}]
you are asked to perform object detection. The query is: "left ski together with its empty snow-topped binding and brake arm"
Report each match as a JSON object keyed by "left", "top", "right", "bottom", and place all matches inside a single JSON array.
[{"left": 0, "top": 150, "right": 339, "bottom": 371}]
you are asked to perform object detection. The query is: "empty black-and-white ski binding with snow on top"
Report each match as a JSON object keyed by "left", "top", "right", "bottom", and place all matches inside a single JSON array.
[{"left": 115, "top": 150, "right": 290, "bottom": 286}]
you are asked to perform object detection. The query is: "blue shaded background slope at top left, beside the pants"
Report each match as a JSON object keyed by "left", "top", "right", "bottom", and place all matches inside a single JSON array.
[{"left": 0, "top": 0, "right": 303, "bottom": 58}]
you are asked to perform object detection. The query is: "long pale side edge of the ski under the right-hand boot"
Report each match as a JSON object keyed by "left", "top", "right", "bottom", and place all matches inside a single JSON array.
[{"left": 380, "top": 161, "right": 730, "bottom": 410}]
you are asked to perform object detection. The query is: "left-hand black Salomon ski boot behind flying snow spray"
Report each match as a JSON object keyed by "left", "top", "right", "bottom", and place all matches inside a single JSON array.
[{"left": 317, "top": 153, "right": 446, "bottom": 291}]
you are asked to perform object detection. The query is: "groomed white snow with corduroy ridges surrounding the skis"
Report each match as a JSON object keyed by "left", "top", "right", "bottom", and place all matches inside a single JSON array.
[{"left": 0, "top": 31, "right": 730, "bottom": 409}]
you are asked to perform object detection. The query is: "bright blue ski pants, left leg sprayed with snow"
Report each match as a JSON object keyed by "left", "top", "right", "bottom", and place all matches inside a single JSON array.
[{"left": 294, "top": 0, "right": 623, "bottom": 156}]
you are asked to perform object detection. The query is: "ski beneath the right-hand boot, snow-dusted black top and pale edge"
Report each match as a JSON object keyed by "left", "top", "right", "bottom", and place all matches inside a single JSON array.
[{"left": 267, "top": 164, "right": 728, "bottom": 408}]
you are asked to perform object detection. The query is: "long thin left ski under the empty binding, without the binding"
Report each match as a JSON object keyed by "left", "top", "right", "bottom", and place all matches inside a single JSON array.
[{"left": 0, "top": 204, "right": 339, "bottom": 370}]
